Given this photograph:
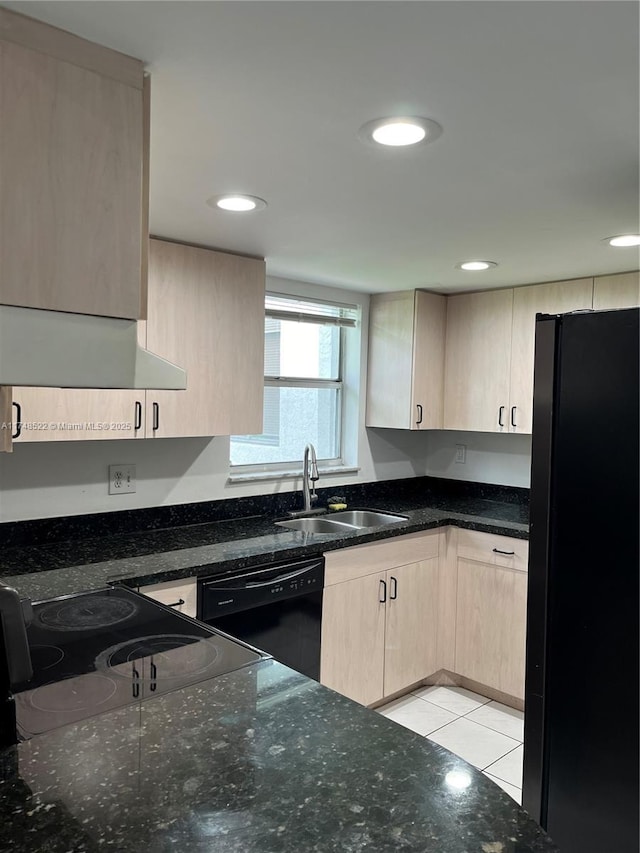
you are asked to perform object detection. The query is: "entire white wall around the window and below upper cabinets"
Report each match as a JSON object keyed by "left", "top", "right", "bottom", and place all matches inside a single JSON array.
[{"left": 0, "top": 278, "right": 531, "bottom": 521}]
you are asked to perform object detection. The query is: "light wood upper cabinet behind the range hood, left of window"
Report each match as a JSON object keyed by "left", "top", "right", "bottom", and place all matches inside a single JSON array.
[{"left": 13, "top": 239, "right": 265, "bottom": 443}]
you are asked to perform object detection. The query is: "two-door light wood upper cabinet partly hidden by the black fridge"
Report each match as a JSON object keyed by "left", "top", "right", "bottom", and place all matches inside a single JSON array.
[{"left": 444, "top": 278, "right": 593, "bottom": 433}]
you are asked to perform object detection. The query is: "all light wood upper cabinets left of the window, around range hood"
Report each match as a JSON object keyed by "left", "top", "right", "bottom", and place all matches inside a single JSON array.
[{"left": 0, "top": 8, "right": 265, "bottom": 449}]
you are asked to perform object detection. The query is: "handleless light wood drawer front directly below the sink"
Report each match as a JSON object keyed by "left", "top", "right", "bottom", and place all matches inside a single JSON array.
[{"left": 324, "top": 530, "right": 443, "bottom": 586}]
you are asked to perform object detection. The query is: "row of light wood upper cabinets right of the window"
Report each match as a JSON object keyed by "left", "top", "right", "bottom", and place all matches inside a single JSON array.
[{"left": 367, "top": 272, "right": 640, "bottom": 433}]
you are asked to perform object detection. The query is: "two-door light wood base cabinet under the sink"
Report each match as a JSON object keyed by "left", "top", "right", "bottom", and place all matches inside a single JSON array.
[{"left": 320, "top": 532, "right": 439, "bottom": 705}]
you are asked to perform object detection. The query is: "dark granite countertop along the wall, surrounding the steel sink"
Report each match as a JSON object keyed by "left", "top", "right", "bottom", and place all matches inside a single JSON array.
[{"left": 0, "top": 493, "right": 529, "bottom": 601}]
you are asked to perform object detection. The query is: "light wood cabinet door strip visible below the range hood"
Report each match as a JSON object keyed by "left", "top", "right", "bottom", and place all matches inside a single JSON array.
[{"left": 13, "top": 388, "right": 145, "bottom": 444}]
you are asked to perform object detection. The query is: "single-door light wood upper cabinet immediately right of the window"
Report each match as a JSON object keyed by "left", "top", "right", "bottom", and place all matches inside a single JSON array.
[{"left": 366, "top": 290, "right": 446, "bottom": 430}]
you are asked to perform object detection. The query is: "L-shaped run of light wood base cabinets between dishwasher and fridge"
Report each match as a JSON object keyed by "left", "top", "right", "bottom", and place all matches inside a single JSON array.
[{"left": 320, "top": 530, "right": 528, "bottom": 705}]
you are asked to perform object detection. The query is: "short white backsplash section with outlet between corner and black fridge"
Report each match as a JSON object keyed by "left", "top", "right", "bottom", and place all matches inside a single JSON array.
[{"left": 425, "top": 430, "right": 531, "bottom": 488}]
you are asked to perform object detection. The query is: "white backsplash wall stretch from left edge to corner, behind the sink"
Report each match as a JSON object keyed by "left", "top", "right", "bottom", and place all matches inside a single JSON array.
[{"left": 0, "top": 431, "right": 436, "bottom": 521}]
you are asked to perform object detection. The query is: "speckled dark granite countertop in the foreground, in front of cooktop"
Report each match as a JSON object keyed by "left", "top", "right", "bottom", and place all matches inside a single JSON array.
[{"left": 0, "top": 661, "right": 557, "bottom": 853}]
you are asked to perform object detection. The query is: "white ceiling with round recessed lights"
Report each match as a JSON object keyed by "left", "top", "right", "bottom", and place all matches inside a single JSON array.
[{"left": 3, "top": 0, "right": 640, "bottom": 292}]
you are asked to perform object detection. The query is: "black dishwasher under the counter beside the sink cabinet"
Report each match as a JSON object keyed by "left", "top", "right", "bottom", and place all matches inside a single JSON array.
[{"left": 198, "top": 557, "right": 324, "bottom": 681}]
